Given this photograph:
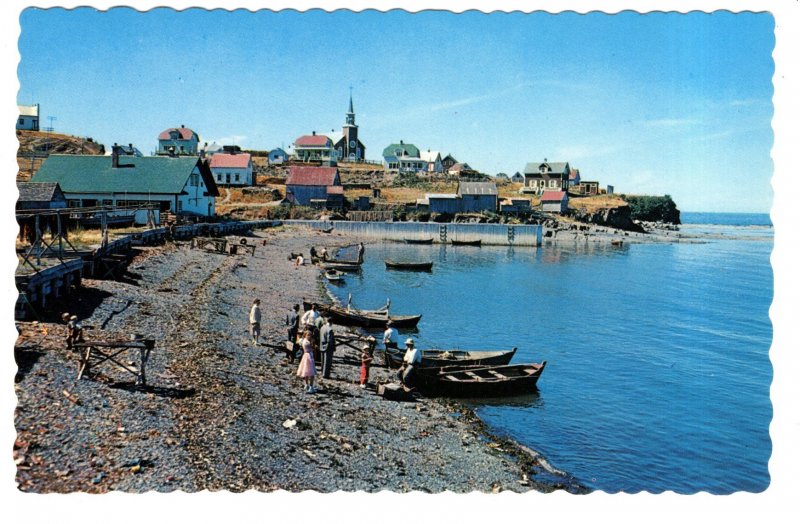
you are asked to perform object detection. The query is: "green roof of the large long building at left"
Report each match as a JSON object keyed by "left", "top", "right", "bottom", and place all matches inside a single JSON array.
[{"left": 31, "top": 155, "right": 219, "bottom": 196}]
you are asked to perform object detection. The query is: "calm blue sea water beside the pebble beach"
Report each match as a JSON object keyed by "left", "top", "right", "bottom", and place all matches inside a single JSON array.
[{"left": 326, "top": 213, "right": 773, "bottom": 494}]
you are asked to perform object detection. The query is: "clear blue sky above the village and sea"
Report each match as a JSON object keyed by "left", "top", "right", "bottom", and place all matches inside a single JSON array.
[{"left": 17, "top": 8, "right": 774, "bottom": 212}]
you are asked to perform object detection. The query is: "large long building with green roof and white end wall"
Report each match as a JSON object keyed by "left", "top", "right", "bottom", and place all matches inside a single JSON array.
[{"left": 31, "top": 148, "right": 219, "bottom": 216}]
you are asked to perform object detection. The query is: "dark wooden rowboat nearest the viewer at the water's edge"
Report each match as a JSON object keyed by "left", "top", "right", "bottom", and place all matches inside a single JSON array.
[{"left": 414, "top": 361, "right": 547, "bottom": 397}]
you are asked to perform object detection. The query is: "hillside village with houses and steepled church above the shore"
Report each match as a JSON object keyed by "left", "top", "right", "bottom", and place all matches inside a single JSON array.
[{"left": 17, "top": 95, "right": 680, "bottom": 231}]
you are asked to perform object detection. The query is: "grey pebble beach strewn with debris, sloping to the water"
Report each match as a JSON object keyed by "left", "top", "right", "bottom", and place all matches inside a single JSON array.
[{"left": 14, "top": 228, "right": 584, "bottom": 492}]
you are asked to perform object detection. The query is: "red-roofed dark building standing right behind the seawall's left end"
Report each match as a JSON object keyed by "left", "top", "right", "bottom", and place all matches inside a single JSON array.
[{"left": 286, "top": 166, "right": 344, "bottom": 209}]
